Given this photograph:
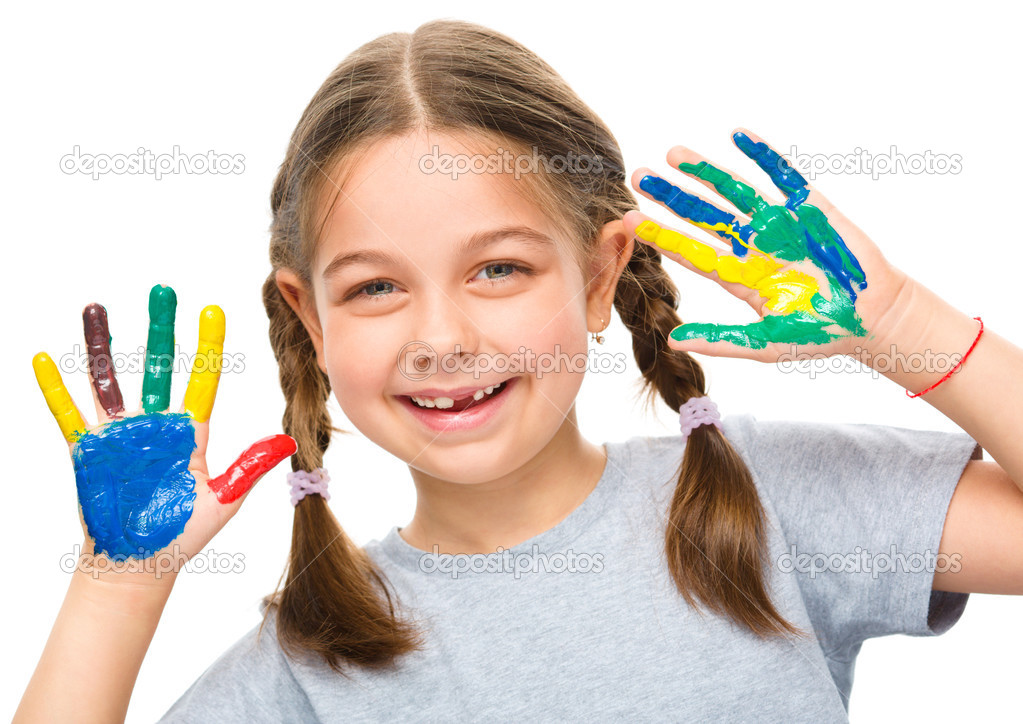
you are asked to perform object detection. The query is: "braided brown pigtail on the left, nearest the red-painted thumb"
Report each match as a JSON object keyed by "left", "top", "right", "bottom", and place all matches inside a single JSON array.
[{"left": 261, "top": 274, "right": 420, "bottom": 674}]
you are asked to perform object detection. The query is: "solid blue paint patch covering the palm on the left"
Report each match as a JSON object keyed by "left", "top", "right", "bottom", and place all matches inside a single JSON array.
[{"left": 72, "top": 413, "right": 195, "bottom": 558}]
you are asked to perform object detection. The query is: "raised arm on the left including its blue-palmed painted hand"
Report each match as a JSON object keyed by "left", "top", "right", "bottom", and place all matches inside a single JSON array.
[{"left": 15, "top": 284, "right": 297, "bottom": 722}]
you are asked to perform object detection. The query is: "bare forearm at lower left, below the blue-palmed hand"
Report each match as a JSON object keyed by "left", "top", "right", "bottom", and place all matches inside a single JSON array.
[{"left": 14, "top": 570, "right": 173, "bottom": 724}]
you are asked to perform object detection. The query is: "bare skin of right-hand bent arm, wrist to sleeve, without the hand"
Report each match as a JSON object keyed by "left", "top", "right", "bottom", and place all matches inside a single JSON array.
[{"left": 878, "top": 281, "right": 1023, "bottom": 595}]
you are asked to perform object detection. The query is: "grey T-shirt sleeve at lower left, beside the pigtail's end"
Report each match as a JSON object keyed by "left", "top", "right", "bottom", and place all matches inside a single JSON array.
[{"left": 153, "top": 617, "right": 317, "bottom": 724}]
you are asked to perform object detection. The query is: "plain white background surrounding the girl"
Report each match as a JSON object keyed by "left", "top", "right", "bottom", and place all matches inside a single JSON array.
[{"left": 0, "top": 0, "right": 1023, "bottom": 722}]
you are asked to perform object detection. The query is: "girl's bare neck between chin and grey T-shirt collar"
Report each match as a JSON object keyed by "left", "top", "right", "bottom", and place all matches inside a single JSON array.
[{"left": 400, "top": 406, "right": 607, "bottom": 553}]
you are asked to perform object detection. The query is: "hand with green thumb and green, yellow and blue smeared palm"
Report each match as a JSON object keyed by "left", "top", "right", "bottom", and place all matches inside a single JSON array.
[{"left": 623, "top": 131, "right": 908, "bottom": 362}]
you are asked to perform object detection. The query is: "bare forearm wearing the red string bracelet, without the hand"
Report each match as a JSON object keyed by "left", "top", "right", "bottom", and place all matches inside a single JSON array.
[{"left": 871, "top": 280, "right": 1023, "bottom": 488}]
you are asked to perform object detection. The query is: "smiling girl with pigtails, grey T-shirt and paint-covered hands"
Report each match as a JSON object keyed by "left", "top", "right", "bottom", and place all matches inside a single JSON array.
[{"left": 17, "top": 21, "right": 1023, "bottom": 722}]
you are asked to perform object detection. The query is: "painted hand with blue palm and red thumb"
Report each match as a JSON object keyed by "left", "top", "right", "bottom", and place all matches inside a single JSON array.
[{"left": 33, "top": 284, "right": 296, "bottom": 580}]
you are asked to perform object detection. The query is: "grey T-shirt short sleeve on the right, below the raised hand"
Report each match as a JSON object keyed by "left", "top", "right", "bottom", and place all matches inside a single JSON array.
[{"left": 725, "top": 415, "right": 981, "bottom": 660}]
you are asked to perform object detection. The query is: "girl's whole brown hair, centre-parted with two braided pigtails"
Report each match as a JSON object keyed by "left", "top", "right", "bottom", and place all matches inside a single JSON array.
[{"left": 263, "top": 15, "right": 803, "bottom": 671}]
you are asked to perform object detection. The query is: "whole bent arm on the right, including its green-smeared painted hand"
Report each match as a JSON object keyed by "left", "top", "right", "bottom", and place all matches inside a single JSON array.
[{"left": 623, "top": 132, "right": 1023, "bottom": 594}]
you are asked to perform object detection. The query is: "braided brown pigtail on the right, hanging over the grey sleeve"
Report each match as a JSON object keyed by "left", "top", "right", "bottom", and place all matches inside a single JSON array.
[{"left": 615, "top": 243, "right": 804, "bottom": 638}]
